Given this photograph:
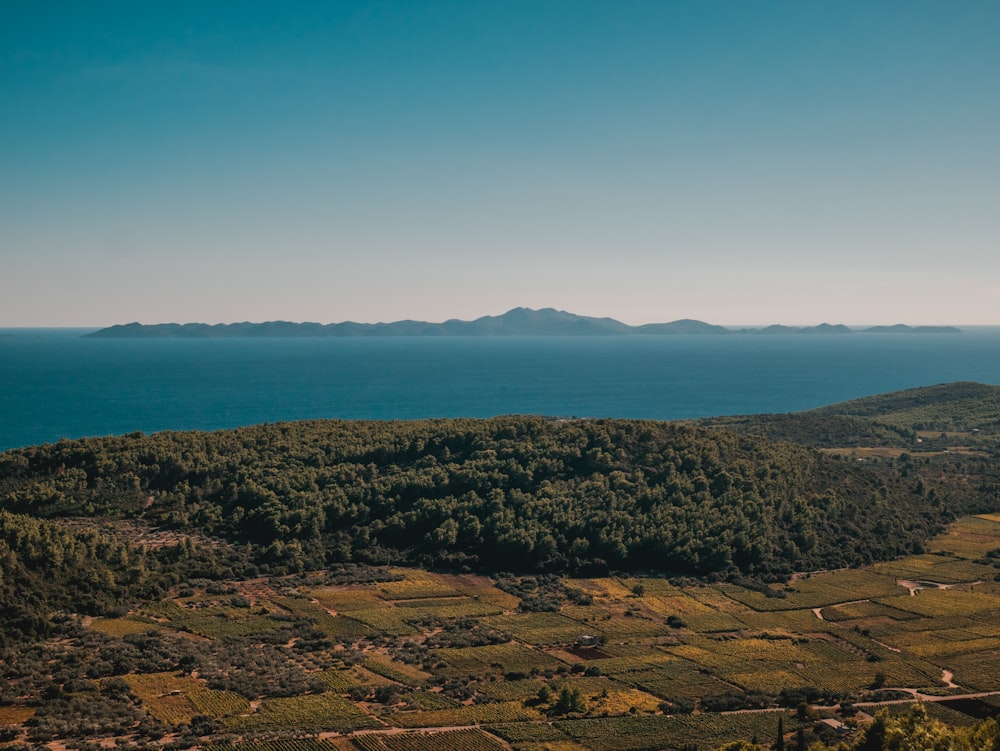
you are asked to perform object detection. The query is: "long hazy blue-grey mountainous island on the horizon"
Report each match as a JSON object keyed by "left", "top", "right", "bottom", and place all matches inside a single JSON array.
[{"left": 85, "top": 308, "right": 961, "bottom": 339}]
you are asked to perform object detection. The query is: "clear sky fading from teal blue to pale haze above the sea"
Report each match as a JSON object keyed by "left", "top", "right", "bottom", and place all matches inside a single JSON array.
[{"left": 0, "top": 0, "right": 1000, "bottom": 327}]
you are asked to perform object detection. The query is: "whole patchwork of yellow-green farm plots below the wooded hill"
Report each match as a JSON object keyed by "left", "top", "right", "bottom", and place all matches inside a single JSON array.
[{"left": 7, "top": 516, "right": 1000, "bottom": 751}]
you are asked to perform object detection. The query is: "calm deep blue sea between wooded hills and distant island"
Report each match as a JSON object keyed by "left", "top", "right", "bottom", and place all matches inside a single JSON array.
[{"left": 0, "top": 327, "right": 1000, "bottom": 450}]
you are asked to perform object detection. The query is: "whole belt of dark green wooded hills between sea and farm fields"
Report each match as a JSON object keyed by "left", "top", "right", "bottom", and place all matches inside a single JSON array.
[{"left": 0, "top": 384, "right": 1000, "bottom": 630}]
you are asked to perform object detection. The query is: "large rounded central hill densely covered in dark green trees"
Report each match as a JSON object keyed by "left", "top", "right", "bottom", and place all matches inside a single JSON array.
[{"left": 0, "top": 417, "right": 976, "bottom": 592}]
